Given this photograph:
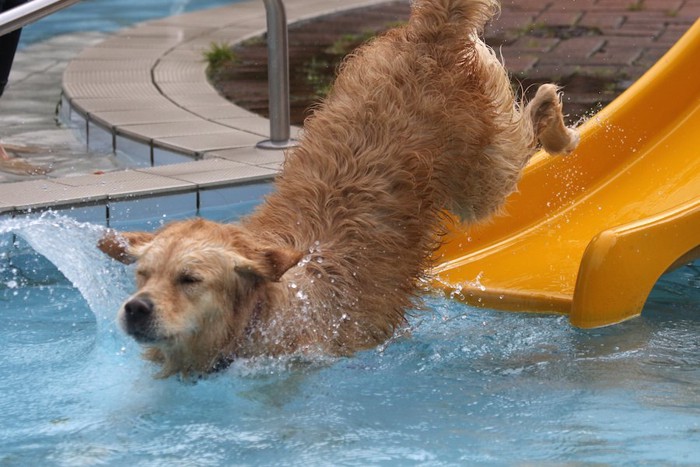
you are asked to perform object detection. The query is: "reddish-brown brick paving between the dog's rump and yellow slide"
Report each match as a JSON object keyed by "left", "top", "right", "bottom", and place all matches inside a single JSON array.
[{"left": 486, "top": 0, "right": 700, "bottom": 118}]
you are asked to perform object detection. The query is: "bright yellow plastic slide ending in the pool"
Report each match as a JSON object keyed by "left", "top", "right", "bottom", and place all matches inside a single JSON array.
[{"left": 434, "top": 20, "right": 700, "bottom": 328}]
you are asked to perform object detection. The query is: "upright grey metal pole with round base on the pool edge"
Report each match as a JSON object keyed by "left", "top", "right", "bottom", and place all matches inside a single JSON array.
[{"left": 257, "top": 0, "right": 297, "bottom": 149}]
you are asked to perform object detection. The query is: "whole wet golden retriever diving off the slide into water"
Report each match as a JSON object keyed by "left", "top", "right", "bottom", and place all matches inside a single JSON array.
[{"left": 99, "top": 0, "right": 578, "bottom": 377}]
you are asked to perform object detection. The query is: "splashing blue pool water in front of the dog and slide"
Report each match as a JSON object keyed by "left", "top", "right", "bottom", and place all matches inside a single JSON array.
[{"left": 0, "top": 209, "right": 700, "bottom": 466}]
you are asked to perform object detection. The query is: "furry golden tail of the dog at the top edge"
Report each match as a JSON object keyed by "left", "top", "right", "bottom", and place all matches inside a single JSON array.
[{"left": 408, "top": 0, "right": 500, "bottom": 43}]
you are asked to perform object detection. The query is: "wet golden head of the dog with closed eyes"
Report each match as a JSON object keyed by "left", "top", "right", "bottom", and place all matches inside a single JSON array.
[{"left": 98, "top": 219, "right": 302, "bottom": 372}]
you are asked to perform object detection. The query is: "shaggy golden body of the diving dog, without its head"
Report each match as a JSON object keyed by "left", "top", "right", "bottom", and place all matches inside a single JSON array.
[{"left": 245, "top": 0, "right": 576, "bottom": 351}]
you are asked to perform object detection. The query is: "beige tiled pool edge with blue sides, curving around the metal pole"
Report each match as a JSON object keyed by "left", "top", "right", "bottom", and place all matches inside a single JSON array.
[{"left": 0, "top": 0, "right": 383, "bottom": 223}]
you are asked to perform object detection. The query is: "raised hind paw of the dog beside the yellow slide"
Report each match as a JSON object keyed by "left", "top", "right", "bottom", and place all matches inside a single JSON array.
[{"left": 525, "top": 84, "right": 579, "bottom": 154}]
